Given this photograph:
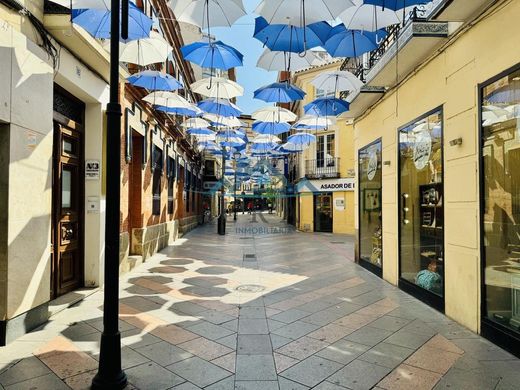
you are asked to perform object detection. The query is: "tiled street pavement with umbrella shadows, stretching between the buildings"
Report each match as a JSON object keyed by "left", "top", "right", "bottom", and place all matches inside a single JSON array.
[{"left": 0, "top": 214, "right": 520, "bottom": 390}]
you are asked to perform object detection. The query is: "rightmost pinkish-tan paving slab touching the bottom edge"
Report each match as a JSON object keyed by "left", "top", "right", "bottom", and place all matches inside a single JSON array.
[{"left": 378, "top": 364, "right": 441, "bottom": 390}]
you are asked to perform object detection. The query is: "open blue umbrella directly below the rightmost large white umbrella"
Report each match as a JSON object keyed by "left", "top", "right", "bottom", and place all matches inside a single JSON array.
[{"left": 323, "top": 24, "right": 387, "bottom": 58}]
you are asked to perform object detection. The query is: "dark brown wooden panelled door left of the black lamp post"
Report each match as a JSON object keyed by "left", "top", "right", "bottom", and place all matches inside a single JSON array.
[{"left": 51, "top": 113, "right": 84, "bottom": 297}]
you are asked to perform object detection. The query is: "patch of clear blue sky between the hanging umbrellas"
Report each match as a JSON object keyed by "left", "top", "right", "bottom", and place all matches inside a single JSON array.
[{"left": 211, "top": 0, "right": 277, "bottom": 114}]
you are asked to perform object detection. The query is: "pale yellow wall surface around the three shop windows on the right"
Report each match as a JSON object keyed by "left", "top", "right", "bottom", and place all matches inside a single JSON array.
[{"left": 355, "top": 1, "right": 520, "bottom": 331}]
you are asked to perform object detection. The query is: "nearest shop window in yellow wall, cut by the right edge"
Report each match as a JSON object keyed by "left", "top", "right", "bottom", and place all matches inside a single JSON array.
[{"left": 481, "top": 70, "right": 520, "bottom": 340}]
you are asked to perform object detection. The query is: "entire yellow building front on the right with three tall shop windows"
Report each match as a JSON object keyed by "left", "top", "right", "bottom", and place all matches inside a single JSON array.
[{"left": 351, "top": 1, "right": 520, "bottom": 353}]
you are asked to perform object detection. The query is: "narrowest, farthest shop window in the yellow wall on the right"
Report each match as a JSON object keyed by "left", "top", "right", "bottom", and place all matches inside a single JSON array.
[{"left": 358, "top": 140, "right": 383, "bottom": 275}]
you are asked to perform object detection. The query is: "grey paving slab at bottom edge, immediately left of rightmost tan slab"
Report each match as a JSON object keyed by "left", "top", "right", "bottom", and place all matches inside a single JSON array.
[{"left": 327, "top": 360, "right": 391, "bottom": 390}]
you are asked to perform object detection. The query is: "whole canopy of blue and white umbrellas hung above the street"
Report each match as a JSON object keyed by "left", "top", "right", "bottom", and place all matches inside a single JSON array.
[{"left": 52, "top": 0, "right": 432, "bottom": 184}]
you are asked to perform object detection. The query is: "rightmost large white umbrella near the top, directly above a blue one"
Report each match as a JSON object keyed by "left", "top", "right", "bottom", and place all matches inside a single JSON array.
[{"left": 339, "top": 4, "right": 401, "bottom": 31}]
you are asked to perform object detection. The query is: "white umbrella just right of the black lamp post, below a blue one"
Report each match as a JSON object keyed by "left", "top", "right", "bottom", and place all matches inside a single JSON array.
[{"left": 119, "top": 31, "right": 173, "bottom": 66}]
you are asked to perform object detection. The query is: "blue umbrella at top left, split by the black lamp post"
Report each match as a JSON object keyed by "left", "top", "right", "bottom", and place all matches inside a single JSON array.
[{"left": 71, "top": 2, "right": 153, "bottom": 41}]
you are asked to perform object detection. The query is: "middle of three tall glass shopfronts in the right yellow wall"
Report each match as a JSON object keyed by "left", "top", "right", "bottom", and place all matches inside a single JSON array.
[{"left": 399, "top": 111, "right": 444, "bottom": 310}]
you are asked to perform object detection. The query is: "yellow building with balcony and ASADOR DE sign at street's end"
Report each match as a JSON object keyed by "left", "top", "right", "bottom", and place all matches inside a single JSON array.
[{"left": 293, "top": 62, "right": 355, "bottom": 234}]
